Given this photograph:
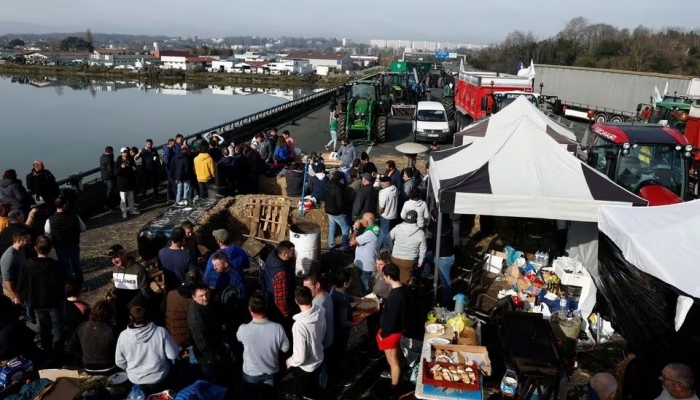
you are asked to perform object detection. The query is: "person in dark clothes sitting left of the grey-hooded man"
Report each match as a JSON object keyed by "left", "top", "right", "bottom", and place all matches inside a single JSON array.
[{"left": 68, "top": 300, "right": 117, "bottom": 375}]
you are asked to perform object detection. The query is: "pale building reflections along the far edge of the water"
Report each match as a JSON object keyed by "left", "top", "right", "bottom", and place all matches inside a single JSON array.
[{"left": 10, "top": 76, "right": 324, "bottom": 101}]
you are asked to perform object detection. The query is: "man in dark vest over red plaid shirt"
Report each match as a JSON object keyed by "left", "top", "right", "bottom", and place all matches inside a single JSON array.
[{"left": 264, "top": 240, "right": 294, "bottom": 329}]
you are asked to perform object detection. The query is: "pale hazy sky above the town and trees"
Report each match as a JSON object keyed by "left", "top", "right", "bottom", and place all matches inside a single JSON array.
[{"left": 0, "top": 0, "right": 700, "bottom": 44}]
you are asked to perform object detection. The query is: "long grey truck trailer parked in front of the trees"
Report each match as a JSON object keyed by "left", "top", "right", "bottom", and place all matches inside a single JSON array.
[{"left": 535, "top": 64, "right": 692, "bottom": 123}]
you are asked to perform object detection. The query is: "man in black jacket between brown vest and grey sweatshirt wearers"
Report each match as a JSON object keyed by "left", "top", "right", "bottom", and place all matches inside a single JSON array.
[{"left": 187, "top": 284, "right": 228, "bottom": 383}]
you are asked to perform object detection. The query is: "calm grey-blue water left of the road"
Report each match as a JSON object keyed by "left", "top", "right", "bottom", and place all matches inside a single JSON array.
[{"left": 0, "top": 76, "right": 318, "bottom": 179}]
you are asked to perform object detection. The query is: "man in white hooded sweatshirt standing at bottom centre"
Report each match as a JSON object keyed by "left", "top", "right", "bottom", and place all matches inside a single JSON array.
[{"left": 287, "top": 286, "right": 326, "bottom": 397}]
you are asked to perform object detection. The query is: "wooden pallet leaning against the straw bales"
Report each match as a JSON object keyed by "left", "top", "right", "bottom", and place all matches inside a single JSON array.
[{"left": 248, "top": 199, "right": 291, "bottom": 242}]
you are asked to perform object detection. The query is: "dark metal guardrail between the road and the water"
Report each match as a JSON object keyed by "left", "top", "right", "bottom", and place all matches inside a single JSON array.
[{"left": 58, "top": 72, "right": 379, "bottom": 185}]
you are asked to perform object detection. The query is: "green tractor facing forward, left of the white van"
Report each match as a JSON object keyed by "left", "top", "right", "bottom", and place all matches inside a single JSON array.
[{"left": 337, "top": 81, "right": 389, "bottom": 144}]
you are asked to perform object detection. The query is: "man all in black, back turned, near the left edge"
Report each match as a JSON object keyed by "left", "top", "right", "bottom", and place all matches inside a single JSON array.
[{"left": 17, "top": 236, "right": 66, "bottom": 356}]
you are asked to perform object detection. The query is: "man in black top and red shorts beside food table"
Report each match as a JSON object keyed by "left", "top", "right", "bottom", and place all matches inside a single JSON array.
[{"left": 376, "top": 264, "right": 409, "bottom": 391}]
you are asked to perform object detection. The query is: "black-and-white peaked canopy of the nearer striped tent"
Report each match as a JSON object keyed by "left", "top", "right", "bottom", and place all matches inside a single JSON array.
[{"left": 430, "top": 98, "right": 647, "bottom": 222}]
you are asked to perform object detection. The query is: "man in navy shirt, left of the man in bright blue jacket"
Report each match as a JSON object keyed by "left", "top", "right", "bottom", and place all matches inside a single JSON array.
[{"left": 158, "top": 226, "right": 197, "bottom": 291}]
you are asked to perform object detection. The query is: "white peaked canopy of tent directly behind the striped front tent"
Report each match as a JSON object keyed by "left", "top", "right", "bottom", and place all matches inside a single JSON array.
[{"left": 454, "top": 96, "right": 577, "bottom": 151}]
